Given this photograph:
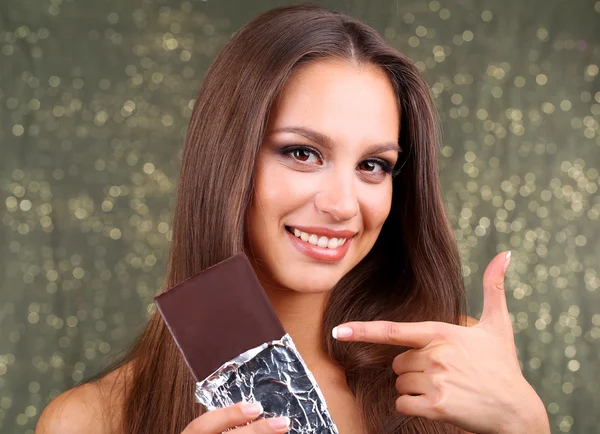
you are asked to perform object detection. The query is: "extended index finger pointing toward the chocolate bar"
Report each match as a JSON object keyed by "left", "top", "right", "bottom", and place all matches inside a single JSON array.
[{"left": 332, "top": 321, "right": 441, "bottom": 348}]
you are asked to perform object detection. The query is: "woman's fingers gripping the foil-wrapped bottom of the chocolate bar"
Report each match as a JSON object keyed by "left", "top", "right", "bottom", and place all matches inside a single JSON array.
[{"left": 181, "top": 403, "right": 290, "bottom": 434}]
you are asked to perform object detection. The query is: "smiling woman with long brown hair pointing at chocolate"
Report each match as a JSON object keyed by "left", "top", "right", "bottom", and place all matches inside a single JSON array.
[{"left": 37, "top": 5, "right": 549, "bottom": 434}]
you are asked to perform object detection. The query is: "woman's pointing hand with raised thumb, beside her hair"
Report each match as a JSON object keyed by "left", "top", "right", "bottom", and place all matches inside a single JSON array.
[{"left": 333, "top": 253, "right": 550, "bottom": 434}]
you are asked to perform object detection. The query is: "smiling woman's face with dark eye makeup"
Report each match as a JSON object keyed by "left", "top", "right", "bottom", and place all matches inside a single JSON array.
[{"left": 247, "top": 60, "right": 400, "bottom": 293}]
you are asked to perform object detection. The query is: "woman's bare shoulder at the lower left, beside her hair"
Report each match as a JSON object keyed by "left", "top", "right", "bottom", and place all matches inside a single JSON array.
[{"left": 35, "top": 365, "right": 130, "bottom": 434}]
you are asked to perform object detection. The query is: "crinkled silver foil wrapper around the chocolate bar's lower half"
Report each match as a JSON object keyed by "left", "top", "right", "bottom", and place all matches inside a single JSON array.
[{"left": 196, "top": 334, "right": 338, "bottom": 434}]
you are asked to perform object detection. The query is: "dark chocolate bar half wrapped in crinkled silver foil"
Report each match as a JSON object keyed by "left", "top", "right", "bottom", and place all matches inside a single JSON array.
[{"left": 155, "top": 253, "right": 338, "bottom": 434}]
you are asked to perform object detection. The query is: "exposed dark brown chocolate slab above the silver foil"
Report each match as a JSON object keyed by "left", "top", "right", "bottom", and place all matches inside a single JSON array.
[{"left": 155, "top": 253, "right": 285, "bottom": 381}]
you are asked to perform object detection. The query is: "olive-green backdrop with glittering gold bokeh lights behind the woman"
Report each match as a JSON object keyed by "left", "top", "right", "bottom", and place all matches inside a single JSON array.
[{"left": 0, "top": 0, "right": 600, "bottom": 434}]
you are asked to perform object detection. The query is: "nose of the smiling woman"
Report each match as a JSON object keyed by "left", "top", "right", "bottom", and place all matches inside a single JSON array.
[{"left": 315, "top": 167, "right": 359, "bottom": 221}]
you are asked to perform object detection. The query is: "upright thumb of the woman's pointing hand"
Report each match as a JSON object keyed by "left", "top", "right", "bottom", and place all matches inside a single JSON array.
[{"left": 480, "top": 250, "right": 512, "bottom": 334}]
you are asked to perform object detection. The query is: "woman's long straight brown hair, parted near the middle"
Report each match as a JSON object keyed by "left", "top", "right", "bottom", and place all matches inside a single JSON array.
[{"left": 89, "top": 5, "right": 465, "bottom": 434}]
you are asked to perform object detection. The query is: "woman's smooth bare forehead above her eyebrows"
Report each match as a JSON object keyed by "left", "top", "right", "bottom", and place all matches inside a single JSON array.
[{"left": 270, "top": 59, "right": 399, "bottom": 139}]
